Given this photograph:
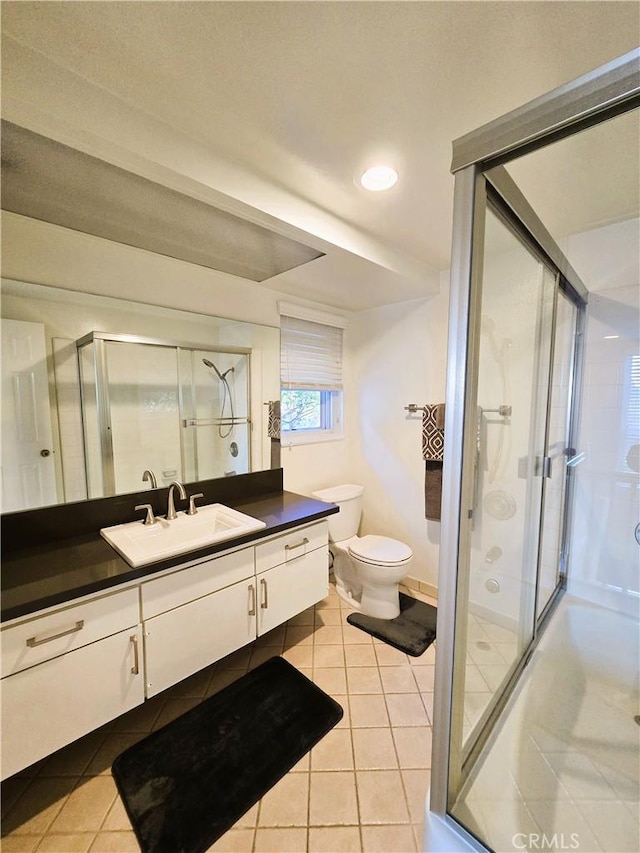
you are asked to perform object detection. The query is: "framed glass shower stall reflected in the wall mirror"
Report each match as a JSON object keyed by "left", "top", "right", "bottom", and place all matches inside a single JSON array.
[{"left": 76, "top": 332, "right": 251, "bottom": 498}]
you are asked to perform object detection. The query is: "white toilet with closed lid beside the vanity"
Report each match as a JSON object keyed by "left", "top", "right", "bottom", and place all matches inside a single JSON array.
[{"left": 311, "top": 484, "right": 413, "bottom": 619}]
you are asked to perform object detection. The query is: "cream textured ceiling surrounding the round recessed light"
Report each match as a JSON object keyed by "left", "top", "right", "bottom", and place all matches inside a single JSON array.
[{"left": 2, "top": 0, "right": 640, "bottom": 307}]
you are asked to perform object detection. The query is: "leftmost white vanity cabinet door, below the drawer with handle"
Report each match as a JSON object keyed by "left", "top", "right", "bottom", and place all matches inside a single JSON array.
[{"left": 1, "top": 626, "right": 144, "bottom": 779}]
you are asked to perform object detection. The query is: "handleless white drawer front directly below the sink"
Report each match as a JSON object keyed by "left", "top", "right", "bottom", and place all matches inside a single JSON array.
[{"left": 142, "top": 548, "right": 254, "bottom": 619}]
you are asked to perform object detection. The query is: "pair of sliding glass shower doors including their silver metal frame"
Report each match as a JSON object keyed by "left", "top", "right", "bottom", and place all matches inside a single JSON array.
[{"left": 434, "top": 167, "right": 582, "bottom": 819}]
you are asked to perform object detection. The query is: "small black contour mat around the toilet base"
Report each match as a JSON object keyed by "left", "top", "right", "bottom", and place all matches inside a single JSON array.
[{"left": 347, "top": 592, "right": 438, "bottom": 657}]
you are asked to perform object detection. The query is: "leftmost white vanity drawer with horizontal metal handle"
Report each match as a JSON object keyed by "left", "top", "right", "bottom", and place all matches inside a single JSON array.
[{"left": 2, "top": 589, "right": 140, "bottom": 678}]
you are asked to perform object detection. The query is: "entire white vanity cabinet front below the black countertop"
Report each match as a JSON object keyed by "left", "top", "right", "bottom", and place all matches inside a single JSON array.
[{"left": 1, "top": 521, "right": 329, "bottom": 778}]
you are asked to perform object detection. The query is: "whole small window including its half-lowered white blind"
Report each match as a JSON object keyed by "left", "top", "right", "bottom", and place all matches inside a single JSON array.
[{"left": 280, "top": 306, "right": 343, "bottom": 444}]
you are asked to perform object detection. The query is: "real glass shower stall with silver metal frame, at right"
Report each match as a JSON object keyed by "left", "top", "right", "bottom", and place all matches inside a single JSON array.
[{"left": 424, "top": 51, "right": 640, "bottom": 853}]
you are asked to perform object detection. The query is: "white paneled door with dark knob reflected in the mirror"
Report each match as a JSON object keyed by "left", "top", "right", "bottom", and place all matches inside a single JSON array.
[{"left": 2, "top": 320, "right": 58, "bottom": 512}]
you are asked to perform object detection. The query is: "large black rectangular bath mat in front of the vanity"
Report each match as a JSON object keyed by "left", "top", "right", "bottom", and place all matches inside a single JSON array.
[{"left": 112, "top": 657, "right": 343, "bottom": 853}]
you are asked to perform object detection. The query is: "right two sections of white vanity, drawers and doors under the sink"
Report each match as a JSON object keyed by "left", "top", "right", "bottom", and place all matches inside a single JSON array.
[{"left": 141, "top": 521, "right": 329, "bottom": 698}]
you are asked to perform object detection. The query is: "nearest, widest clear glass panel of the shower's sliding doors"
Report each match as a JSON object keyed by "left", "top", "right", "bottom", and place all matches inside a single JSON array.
[{"left": 456, "top": 209, "right": 555, "bottom": 756}]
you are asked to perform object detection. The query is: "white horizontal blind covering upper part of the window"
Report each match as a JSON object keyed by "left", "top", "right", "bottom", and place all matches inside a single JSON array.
[{"left": 280, "top": 314, "right": 342, "bottom": 391}]
